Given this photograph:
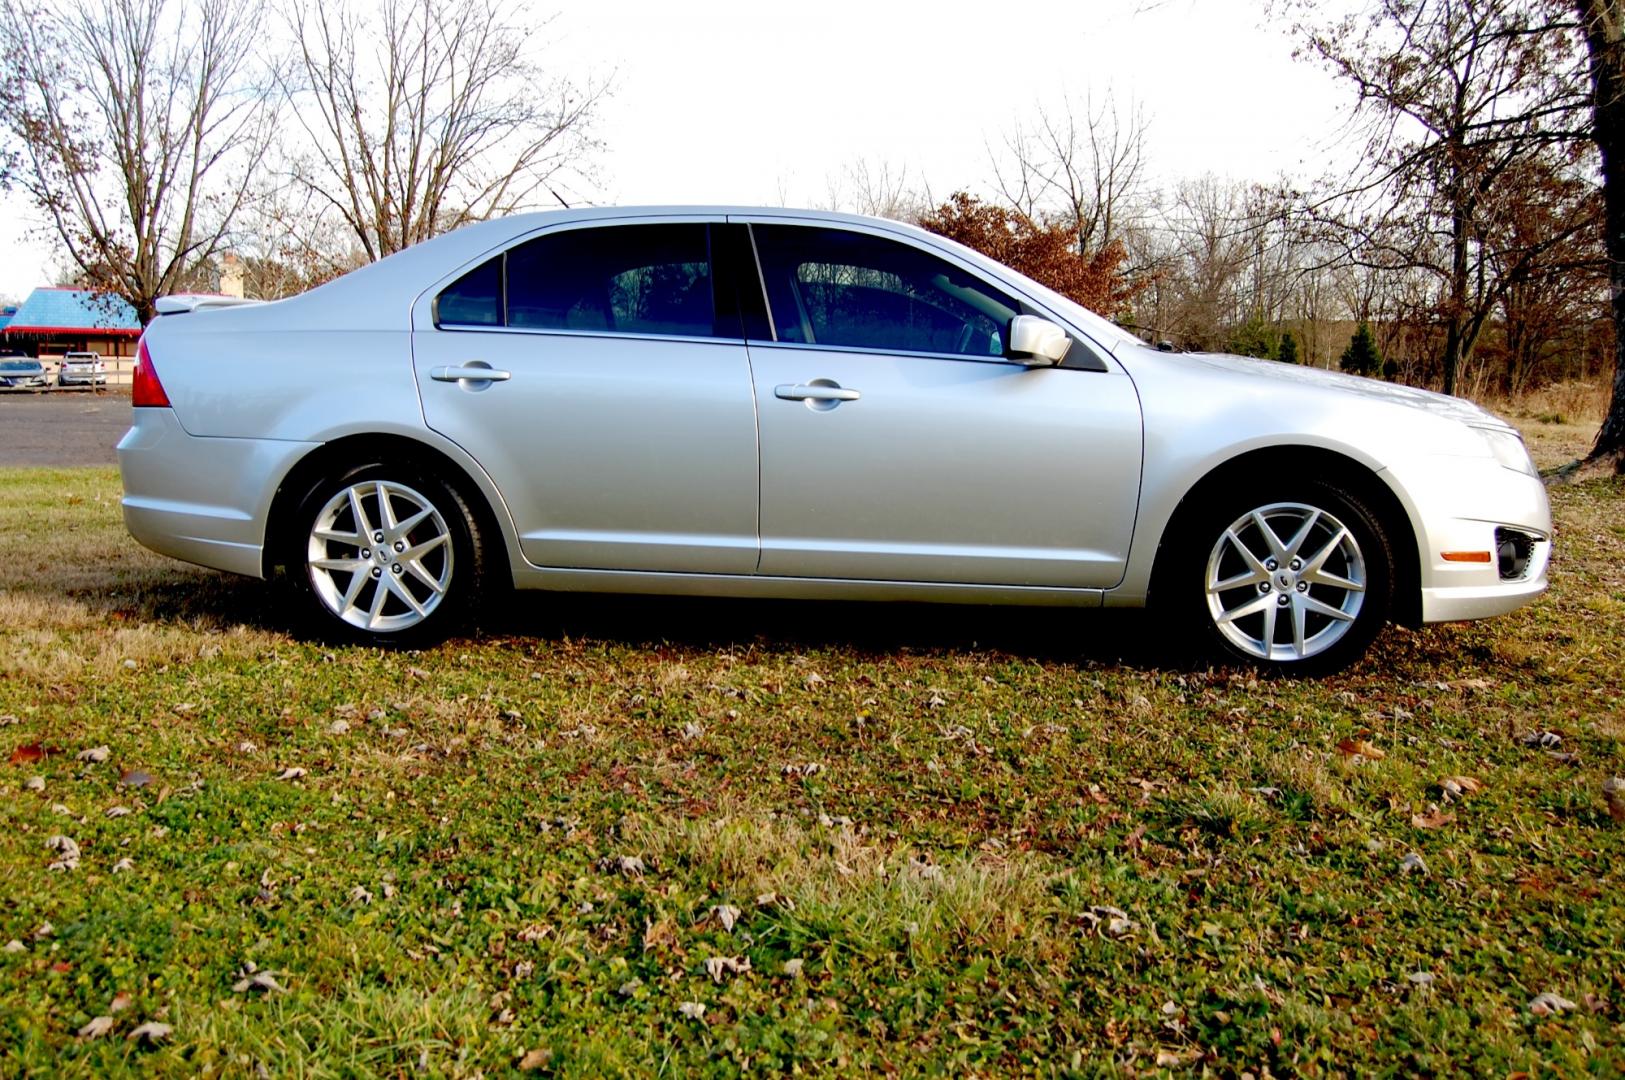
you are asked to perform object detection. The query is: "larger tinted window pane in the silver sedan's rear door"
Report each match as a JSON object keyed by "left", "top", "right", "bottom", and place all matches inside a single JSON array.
[{"left": 507, "top": 224, "right": 715, "bottom": 338}]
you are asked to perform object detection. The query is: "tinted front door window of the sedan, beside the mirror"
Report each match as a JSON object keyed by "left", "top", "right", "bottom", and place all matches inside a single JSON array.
[{"left": 752, "top": 226, "right": 1021, "bottom": 357}]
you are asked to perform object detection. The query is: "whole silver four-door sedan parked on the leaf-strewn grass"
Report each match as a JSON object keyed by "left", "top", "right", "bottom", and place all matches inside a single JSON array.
[{"left": 119, "top": 208, "right": 1552, "bottom": 672}]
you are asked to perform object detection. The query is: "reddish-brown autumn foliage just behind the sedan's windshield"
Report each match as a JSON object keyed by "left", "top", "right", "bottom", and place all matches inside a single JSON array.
[{"left": 920, "top": 192, "right": 1147, "bottom": 318}]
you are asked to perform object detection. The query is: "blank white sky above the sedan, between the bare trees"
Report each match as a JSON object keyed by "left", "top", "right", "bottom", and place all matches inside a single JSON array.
[{"left": 0, "top": 0, "right": 1349, "bottom": 299}]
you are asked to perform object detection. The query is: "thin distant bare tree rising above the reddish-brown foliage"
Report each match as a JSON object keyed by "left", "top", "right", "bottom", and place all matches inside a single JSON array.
[{"left": 993, "top": 94, "right": 1147, "bottom": 258}]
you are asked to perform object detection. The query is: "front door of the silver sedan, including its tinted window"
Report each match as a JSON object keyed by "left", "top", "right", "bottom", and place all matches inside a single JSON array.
[{"left": 749, "top": 221, "right": 1141, "bottom": 588}]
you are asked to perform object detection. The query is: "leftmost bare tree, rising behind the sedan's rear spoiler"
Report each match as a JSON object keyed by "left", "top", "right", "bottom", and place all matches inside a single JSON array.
[{"left": 0, "top": 0, "right": 271, "bottom": 323}]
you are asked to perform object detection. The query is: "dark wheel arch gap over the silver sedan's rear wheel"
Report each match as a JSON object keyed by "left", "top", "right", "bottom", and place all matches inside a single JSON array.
[{"left": 260, "top": 432, "right": 509, "bottom": 578}]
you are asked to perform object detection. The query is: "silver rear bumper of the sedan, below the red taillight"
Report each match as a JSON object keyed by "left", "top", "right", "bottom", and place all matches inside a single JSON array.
[{"left": 119, "top": 408, "right": 319, "bottom": 578}]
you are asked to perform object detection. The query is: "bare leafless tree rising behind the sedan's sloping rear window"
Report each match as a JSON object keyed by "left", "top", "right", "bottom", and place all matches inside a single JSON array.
[{"left": 284, "top": 0, "right": 605, "bottom": 258}]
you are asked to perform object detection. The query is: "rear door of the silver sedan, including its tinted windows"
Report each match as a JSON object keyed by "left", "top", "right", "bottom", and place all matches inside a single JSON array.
[{"left": 413, "top": 218, "right": 757, "bottom": 573}]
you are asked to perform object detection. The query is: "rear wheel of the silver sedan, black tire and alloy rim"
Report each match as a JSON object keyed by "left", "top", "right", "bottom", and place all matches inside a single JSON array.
[{"left": 280, "top": 461, "right": 486, "bottom": 648}]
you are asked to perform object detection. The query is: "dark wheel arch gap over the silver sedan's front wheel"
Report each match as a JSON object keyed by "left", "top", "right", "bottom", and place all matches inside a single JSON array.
[{"left": 1146, "top": 445, "right": 1422, "bottom": 627}]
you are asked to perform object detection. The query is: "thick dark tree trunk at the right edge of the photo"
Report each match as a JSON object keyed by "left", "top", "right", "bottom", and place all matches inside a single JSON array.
[{"left": 1576, "top": 0, "right": 1625, "bottom": 457}]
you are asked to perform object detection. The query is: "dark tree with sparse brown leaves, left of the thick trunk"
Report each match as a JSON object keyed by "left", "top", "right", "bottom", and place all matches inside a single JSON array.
[{"left": 1298, "top": 0, "right": 1583, "bottom": 393}]
